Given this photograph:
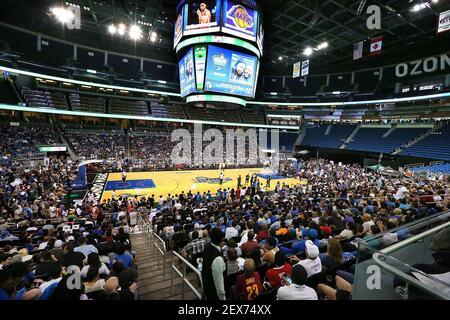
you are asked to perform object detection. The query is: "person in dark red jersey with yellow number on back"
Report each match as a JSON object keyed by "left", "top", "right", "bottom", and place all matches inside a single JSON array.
[{"left": 236, "top": 259, "right": 263, "bottom": 300}]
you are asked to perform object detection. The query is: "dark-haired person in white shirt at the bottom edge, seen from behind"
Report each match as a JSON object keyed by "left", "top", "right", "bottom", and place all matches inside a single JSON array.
[{"left": 277, "top": 264, "right": 318, "bottom": 300}]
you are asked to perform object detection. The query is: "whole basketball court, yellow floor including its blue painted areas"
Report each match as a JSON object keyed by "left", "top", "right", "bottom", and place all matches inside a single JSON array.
[{"left": 101, "top": 168, "right": 306, "bottom": 201}]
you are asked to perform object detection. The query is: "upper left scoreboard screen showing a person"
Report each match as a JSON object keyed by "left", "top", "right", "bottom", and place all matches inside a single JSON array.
[{"left": 184, "top": 0, "right": 222, "bottom": 35}]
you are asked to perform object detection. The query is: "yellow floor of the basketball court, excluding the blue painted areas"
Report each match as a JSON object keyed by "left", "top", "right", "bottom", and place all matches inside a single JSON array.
[{"left": 101, "top": 168, "right": 306, "bottom": 201}]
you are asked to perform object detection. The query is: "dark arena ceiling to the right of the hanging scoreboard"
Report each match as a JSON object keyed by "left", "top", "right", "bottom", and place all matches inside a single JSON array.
[{"left": 261, "top": 0, "right": 450, "bottom": 72}]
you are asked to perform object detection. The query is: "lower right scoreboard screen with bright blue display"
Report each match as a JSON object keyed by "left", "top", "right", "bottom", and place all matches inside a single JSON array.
[{"left": 205, "top": 45, "right": 259, "bottom": 97}]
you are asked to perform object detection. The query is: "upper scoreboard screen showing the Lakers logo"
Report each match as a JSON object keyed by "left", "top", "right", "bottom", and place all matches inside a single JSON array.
[{"left": 222, "top": 0, "right": 258, "bottom": 41}]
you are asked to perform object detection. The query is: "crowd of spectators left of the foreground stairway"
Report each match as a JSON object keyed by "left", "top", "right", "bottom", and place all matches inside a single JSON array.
[{"left": 0, "top": 158, "right": 140, "bottom": 300}]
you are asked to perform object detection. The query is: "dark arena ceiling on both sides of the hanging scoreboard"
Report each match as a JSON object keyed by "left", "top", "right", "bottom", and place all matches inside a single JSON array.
[{"left": 0, "top": 0, "right": 450, "bottom": 74}]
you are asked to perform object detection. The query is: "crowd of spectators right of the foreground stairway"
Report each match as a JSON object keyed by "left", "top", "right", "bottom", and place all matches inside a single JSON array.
[{"left": 150, "top": 159, "right": 450, "bottom": 300}]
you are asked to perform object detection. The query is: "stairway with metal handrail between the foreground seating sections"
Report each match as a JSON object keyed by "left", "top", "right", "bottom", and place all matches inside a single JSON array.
[{"left": 131, "top": 231, "right": 197, "bottom": 300}]
